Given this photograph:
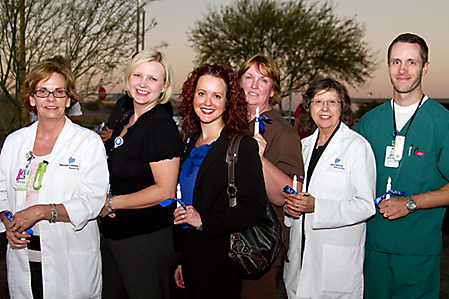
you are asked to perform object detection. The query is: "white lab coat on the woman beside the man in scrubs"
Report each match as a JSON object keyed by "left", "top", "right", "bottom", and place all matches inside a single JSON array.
[{"left": 284, "top": 123, "right": 376, "bottom": 299}]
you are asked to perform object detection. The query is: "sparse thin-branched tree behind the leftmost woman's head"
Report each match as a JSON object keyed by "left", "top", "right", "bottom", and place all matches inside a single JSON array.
[{"left": 0, "top": 0, "right": 156, "bottom": 131}]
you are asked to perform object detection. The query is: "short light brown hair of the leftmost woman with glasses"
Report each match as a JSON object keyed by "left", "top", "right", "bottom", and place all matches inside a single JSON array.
[{"left": 19, "top": 55, "right": 81, "bottom": 113}]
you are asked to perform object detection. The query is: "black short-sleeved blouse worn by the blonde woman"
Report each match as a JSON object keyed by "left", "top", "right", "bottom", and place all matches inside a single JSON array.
[{"left": 101, "top": 105, "right": 184, "bottom": 239}]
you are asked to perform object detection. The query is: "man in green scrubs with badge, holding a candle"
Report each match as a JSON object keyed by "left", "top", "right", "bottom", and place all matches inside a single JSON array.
[{"left": 357, "top": 33, "right": 449, "bottom": 299}]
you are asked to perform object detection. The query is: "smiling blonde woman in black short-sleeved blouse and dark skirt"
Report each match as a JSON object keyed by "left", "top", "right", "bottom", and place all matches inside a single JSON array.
[{"left": 101, "top": 50, "right": 184, "bottom": 298}]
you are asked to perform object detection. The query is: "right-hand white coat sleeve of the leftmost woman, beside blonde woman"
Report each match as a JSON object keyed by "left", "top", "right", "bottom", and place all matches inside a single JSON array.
[{"left": 62, "top": 134, "right": 109, "bottom": 230}]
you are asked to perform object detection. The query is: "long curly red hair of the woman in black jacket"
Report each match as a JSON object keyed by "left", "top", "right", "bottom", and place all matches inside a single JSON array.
[{"left": 179, "top": 64, "right": 248, "bottom": 137}]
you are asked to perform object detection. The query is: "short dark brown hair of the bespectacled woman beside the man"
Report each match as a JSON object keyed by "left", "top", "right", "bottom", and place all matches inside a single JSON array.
[{"left": 299, "top": 78, "right": 354, "bottom": 132}]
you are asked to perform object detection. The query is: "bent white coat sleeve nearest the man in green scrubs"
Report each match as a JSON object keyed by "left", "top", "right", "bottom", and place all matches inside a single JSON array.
[{"left": 312, "top": 138, "right": 376, "bottom": 229}]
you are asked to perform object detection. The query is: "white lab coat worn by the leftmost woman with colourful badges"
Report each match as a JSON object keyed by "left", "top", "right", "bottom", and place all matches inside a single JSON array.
[{"left": 0, "top": 118, "right": 108, "bottom": 298}]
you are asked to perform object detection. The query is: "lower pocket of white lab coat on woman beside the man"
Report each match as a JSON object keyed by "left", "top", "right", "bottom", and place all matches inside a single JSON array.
[{"left": 321, "top": 245, "right": 363, "bottom": 295}]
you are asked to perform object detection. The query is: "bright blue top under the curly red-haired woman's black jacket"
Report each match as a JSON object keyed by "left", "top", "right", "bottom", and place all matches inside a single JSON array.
[{"left": 179, "top": 141, "right": 215, "bottom": 228}]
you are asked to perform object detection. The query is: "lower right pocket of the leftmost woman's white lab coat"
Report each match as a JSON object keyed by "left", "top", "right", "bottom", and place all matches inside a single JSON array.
[{"left": 69, "top": 250, "right": 102, "bottom": 298}]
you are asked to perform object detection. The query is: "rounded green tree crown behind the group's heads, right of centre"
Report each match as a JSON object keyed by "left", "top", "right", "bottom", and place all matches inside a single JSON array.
[{"left": 189, "top": 0, "right": 377, "bottom": 95}]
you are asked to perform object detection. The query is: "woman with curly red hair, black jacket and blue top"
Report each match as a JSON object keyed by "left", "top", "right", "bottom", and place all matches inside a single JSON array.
[{"left": 174, "top": 64, "right": 268, "bottom": 299}]
